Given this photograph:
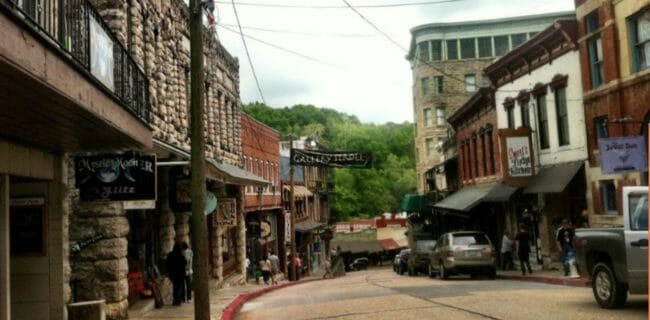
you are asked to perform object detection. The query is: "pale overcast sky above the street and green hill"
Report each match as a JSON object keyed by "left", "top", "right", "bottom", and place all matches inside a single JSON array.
[{"left": 209, "top": 0, "right": 574, "bottom": 124}]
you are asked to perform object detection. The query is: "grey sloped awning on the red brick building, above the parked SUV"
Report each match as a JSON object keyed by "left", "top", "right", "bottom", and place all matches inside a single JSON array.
[{"left": 434, "top": 183, "right": 517, "bottom": 211}]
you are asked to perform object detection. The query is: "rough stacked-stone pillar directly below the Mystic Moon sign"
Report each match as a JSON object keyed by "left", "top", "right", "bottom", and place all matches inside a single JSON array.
[{"left": 70, "top": 201, "right": 129, "bottom": 319}]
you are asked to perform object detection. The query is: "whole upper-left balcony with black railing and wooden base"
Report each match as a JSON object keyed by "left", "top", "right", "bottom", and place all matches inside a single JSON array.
[{"left": 0, "top": 0, "right": 152, "bottom": 151}]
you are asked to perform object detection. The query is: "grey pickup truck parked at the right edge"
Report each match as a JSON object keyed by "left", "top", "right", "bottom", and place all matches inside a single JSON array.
[{"left": 574, "top": 186, "right": 648, "bottom": 309}]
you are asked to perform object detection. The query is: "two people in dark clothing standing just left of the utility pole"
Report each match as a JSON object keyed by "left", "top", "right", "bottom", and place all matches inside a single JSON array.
[{"left": 167, "top": 242, "right": 194, "bottom": 306}]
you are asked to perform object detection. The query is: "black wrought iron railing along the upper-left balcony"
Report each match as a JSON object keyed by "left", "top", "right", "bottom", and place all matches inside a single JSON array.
[{"left": 0, "top": 0, "right": 151, "bottom": 123}]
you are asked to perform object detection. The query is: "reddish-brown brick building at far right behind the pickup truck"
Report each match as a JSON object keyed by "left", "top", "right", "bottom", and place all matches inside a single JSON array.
[{"left": 575, "top": 0, "right": 650, "bottom": 225}]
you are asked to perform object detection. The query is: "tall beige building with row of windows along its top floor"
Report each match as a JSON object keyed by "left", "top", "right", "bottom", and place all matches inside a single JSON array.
[{"left": 407, "top": 12, "right": 574, "bottom": 193}]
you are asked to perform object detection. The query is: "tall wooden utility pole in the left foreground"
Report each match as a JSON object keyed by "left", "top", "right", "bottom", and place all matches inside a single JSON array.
[{"left": 190, "top": 0, "right": 210, "bottom": 320}]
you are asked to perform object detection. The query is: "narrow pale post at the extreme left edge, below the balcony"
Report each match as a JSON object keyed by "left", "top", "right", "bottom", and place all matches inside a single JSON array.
[{"left": 0, "top": 174, "right": 11, "bottom": 320}]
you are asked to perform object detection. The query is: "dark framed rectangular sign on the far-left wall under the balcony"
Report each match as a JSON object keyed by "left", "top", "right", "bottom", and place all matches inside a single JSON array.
[{"left": 9, "top": 197, "right": 46, "bottom": 255}]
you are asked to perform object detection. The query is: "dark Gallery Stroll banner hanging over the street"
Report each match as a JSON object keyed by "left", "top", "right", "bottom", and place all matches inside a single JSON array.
[{"left": 291, "top": 149, "right": 372, "bottom": 169}]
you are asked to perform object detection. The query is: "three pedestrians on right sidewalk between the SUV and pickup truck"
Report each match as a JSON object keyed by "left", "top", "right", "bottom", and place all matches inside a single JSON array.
[{"left": 500, "top": 219, "right": 574, "bottom": 276}]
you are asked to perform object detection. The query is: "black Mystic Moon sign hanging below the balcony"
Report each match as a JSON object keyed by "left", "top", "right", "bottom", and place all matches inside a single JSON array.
[{"left": 74, "top": 153, "right": 156, "bottom": 201}]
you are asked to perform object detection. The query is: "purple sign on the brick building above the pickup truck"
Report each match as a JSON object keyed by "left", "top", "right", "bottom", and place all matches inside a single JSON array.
[{"left": 598, "top": 136, "right": 648, "bottom": 174}]
